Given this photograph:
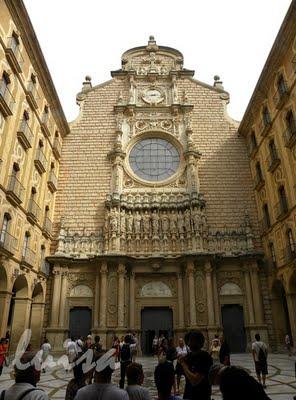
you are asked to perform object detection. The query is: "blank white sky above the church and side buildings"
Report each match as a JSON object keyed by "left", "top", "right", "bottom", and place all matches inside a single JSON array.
[{"left": 24, "top": 0, "right": 290, "bottom": 121}]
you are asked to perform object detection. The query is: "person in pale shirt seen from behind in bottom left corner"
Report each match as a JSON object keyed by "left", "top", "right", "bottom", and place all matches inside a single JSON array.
[{"left": 0, "top": 352, "right": 48, "bottom": 400}]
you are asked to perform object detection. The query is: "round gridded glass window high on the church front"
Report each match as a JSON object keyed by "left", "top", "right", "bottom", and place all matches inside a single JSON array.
[{"left": 129, "top": 138, "right": 180, "bottom": 182}]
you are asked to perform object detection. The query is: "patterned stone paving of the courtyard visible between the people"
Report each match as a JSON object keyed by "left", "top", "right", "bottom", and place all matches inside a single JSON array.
[{"left": 0, "top": 354, "right": 296, "bottom": 400}]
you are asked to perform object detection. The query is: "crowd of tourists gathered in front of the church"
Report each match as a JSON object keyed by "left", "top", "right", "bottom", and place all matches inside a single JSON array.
[{"left": 0, "top": 331, "right": 280, "bottom": 400}]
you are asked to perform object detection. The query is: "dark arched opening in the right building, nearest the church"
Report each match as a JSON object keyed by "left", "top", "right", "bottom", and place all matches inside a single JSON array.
[{"left": 271, "top": 280, "right": 291, "bottom": 347}]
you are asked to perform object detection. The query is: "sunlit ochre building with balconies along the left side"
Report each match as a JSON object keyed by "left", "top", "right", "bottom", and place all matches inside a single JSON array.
[{"left": 0, "top": 0, "right": 68, "bottom": 349}]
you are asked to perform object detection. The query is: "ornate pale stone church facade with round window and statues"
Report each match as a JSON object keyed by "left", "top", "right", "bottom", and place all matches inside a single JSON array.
[{"left": 46, "top": 37, "right": 271, "bottom": 352}]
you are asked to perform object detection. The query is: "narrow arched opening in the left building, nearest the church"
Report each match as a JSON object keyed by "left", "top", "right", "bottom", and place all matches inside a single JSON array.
[{"left": 30, "top": 283, "right": 45, "bottom": 349}]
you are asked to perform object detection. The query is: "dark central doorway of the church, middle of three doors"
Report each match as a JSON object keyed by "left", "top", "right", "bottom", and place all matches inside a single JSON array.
[{"left": 141, "top": 307, "right": 173, "bottom": 355}]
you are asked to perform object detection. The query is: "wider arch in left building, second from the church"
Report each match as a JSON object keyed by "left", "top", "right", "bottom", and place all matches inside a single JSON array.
[{"left": 8, "top": 275, "right": 31, "bottom": 350}]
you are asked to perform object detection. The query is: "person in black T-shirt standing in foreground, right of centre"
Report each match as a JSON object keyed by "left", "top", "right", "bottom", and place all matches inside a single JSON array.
[{"left": 179, "top": 331, "right": 213, "bottom": 400}]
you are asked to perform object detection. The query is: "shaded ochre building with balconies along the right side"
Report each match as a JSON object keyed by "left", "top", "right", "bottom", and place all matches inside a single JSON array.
[{"left": 239, "top": 1, "right": 296, "bottom": 347}]
